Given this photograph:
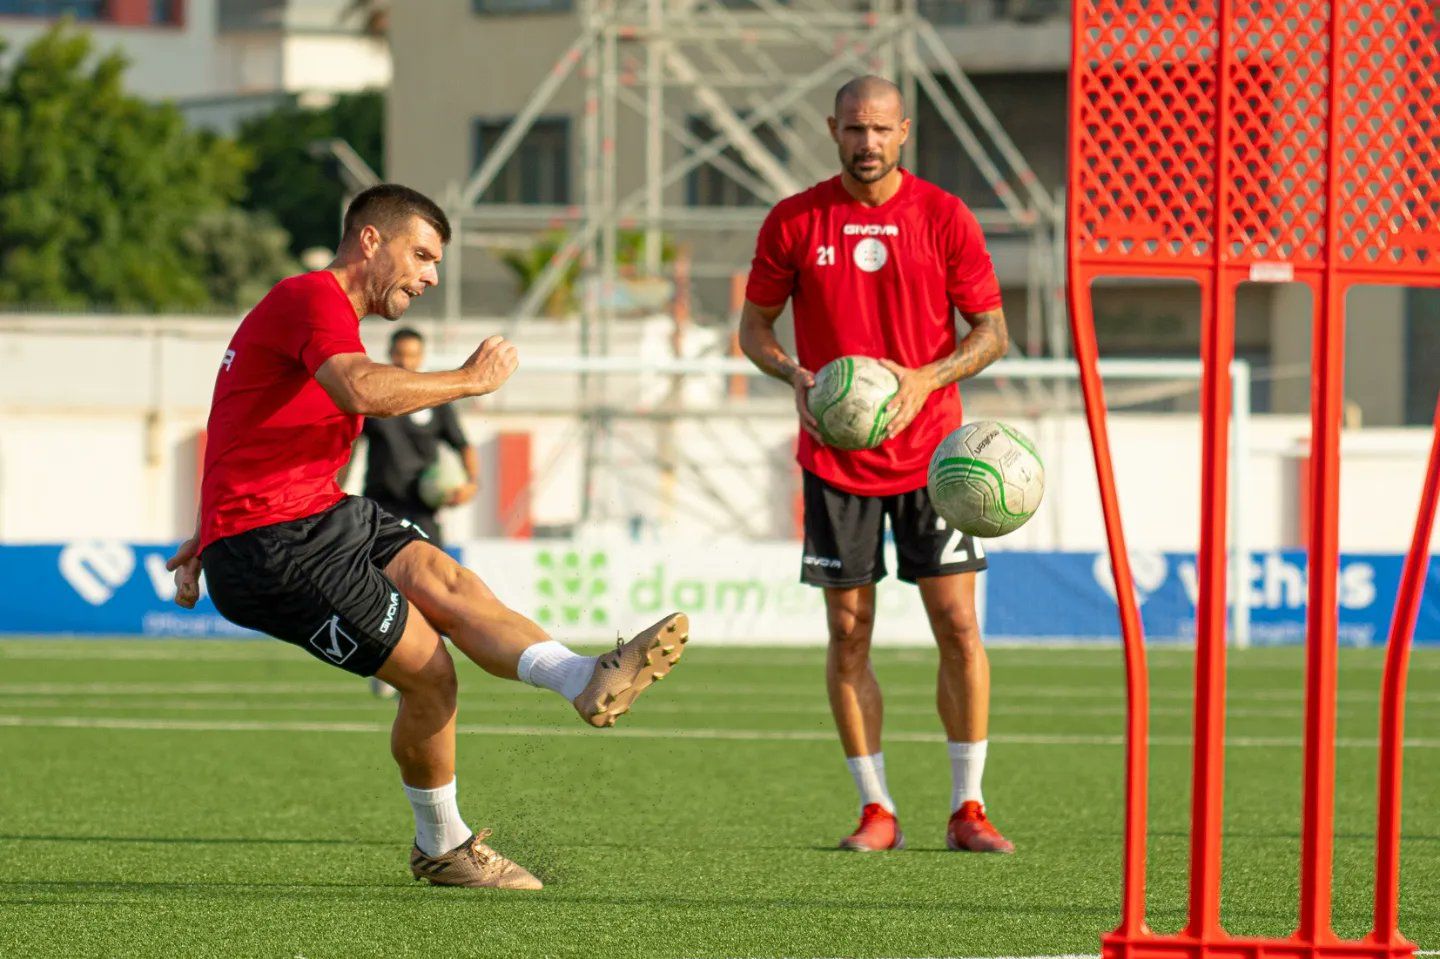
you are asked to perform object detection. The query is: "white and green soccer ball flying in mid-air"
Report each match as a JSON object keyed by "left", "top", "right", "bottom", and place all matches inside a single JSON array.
[{"left": 929, "top": 420, "right": 1045, "bottom": 537}]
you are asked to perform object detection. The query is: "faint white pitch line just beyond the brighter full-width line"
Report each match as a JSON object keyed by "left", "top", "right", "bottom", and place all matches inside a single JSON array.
[{"left": 0, "top": 680, "right": 1440, "bottom": 711}]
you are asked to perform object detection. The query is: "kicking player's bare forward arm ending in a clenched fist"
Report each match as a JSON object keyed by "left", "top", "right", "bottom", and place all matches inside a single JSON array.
[{"left": 315, "top": 336, "right": 520, "bottom": 416}]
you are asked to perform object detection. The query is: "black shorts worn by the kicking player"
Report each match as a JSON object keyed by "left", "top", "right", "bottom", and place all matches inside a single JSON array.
[{"left": 200, "top": 497, "right": 426, "bottom": 675}]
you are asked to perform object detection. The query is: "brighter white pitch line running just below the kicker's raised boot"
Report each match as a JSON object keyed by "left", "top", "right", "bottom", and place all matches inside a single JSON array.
[{"left": 0, "top": 716, "right": 1440, "bottom": 749}]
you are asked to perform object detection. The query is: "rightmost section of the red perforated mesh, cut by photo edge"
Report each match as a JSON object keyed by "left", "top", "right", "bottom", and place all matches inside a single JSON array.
[{"left": 1336, "top": 0, "right": 1440, "bottom": 272}]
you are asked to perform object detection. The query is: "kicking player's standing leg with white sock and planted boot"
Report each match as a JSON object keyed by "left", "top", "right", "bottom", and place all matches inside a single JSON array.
[{"left": 376, "top": 609, "right": 540, "bottom": 890}]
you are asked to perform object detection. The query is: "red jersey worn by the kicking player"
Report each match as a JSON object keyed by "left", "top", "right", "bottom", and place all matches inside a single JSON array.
[{"left": 200, "top": 271, "right": 364, "bottom": 550}]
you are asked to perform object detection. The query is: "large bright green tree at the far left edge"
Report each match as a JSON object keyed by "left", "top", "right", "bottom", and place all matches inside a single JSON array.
[{"left": 0, "top": 23, "right": 263, "bottom": 310}]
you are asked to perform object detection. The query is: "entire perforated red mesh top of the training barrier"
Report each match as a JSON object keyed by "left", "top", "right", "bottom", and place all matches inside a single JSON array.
[{"left": 1071, "top": 0, "right": 1440, "bottom": 276}]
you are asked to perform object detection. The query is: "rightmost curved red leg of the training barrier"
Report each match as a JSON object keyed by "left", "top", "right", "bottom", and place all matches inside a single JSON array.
[{"left": 1371, "top": 397, "right": 1440, "bottom": 946}]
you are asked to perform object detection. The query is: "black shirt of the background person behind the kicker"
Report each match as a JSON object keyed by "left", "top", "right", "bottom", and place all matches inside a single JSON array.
[{"left": 364, "top": 406, "right": 469, "bottom": 546}]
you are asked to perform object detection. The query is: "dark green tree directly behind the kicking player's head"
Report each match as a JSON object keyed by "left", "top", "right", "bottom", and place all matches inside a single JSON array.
[{"left": 239, "top": 92, "right": 384, "bottom": 255}]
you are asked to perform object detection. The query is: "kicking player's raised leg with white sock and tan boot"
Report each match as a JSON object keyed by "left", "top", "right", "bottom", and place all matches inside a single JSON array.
[{"left": 384, "top": 541, "right": 690, "bottom": 726}]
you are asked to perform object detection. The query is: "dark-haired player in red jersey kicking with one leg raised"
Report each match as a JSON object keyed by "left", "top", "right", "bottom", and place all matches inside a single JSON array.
[{"left": 168, "top": 184, "right": 688, "bottom": 888}]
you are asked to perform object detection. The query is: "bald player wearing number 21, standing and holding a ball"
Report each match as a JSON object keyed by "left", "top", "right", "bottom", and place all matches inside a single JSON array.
[{"left": 740, "top": 76, "right": 1014, "bottom": 852}]
